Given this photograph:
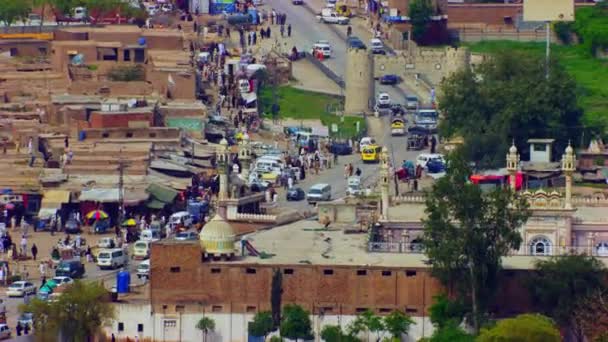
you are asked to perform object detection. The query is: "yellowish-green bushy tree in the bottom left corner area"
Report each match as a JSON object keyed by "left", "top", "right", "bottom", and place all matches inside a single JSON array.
[{"left": 19, "top": 281, "right": 114, "bottom": 342}]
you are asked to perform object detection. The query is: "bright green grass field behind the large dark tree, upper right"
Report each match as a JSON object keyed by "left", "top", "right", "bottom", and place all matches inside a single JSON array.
[{"left": 465, "top": 41, "right": 608, "bottom": 127}]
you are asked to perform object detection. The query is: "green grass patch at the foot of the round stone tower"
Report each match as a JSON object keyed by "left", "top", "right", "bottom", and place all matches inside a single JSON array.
[{"left": 260, "top": 86, "right": 365, "bottom": 138}]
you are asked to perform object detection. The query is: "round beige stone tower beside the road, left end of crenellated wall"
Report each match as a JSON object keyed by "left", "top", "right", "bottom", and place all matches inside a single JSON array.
[{"left": 344, "top": 48, "right": 374, "bottom": 115}]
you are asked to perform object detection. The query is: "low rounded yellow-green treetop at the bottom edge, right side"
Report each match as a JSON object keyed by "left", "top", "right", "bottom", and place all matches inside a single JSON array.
[{"left": 476, "top": 314, "right": 562, "bottom": 342}]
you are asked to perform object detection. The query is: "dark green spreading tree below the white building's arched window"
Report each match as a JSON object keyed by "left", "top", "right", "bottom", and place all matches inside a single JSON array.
[{"left": 529, "top": 255, "right": 606, "bottom": 338}]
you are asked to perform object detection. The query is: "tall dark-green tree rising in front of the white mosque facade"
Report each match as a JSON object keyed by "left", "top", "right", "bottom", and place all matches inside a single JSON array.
[{"left": 423, "top": 151, "right": 529, "bottom": 331}]
